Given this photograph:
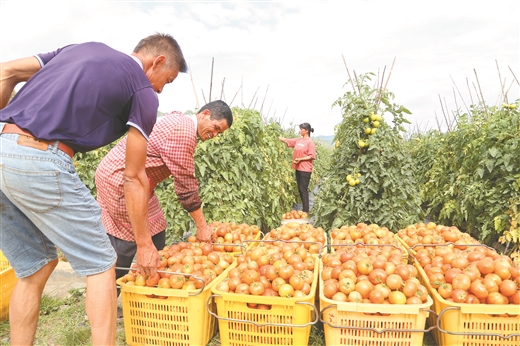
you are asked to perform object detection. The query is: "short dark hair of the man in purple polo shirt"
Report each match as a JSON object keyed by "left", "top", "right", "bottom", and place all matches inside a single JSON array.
[{"left": 134, "top": 33, "right": 188, "bottom": 73}]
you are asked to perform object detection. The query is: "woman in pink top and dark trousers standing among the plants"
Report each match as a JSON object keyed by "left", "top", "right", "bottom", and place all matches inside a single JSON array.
[{"left": 280, "top": 123, "right": 316, "bottom": 213}]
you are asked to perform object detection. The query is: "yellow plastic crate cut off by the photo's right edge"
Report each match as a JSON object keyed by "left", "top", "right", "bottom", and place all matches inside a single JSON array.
[{"left": 414, "top": 263, "right": 520, "bottom": 346}]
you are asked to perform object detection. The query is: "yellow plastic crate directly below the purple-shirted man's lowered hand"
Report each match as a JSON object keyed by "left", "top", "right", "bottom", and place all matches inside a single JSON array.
[{"left": 116, "top": 262, "right": 236, "bottom": 346}]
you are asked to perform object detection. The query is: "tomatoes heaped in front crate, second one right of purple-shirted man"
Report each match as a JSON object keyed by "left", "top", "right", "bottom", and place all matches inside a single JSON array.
[{"left": 215, "top": 241, "right": 318, "bottom": 310}]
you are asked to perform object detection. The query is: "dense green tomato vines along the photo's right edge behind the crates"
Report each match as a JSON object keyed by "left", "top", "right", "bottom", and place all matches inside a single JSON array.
[{"left": 411, "top": 101, "right": 520, "bottom": 245}]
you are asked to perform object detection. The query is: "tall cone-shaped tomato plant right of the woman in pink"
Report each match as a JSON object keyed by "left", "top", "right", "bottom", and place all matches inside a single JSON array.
[{"left": 314, "top": 74, "right": 421, "bottom": 231}]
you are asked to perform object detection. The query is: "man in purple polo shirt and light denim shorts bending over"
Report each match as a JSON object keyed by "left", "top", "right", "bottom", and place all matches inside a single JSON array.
[{"left": 0, "top": 34, "right": 187, "bottom": 345}]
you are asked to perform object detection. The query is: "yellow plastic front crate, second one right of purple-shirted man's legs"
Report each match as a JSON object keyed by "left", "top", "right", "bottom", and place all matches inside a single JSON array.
[{"left": 208, "top": 261, "right": 319, "bottom": 346}]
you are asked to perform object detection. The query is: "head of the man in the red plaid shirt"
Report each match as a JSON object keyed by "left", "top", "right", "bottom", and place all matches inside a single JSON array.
[{"left": 197, "top": 100, "right": 233, "bottom": 141}]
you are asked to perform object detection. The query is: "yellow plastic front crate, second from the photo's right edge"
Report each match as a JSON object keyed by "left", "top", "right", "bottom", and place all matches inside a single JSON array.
[{"left": 319, "top": 262, "right": 433, "bottom": 346}]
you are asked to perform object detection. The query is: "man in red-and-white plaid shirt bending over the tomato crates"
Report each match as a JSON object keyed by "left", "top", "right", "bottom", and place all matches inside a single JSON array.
[{"left": 95, "top": 101, "right": 233, "bottom": 284}]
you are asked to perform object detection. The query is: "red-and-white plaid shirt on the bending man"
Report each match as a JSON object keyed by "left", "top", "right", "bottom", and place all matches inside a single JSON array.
[{"left": 95, "top": 112, "right": 202, "bottom": 242}]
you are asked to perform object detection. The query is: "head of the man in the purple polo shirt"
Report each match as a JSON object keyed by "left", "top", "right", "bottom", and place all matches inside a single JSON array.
[{"left": 133, "top": 33, "right": 188, "bottom": 94}]
